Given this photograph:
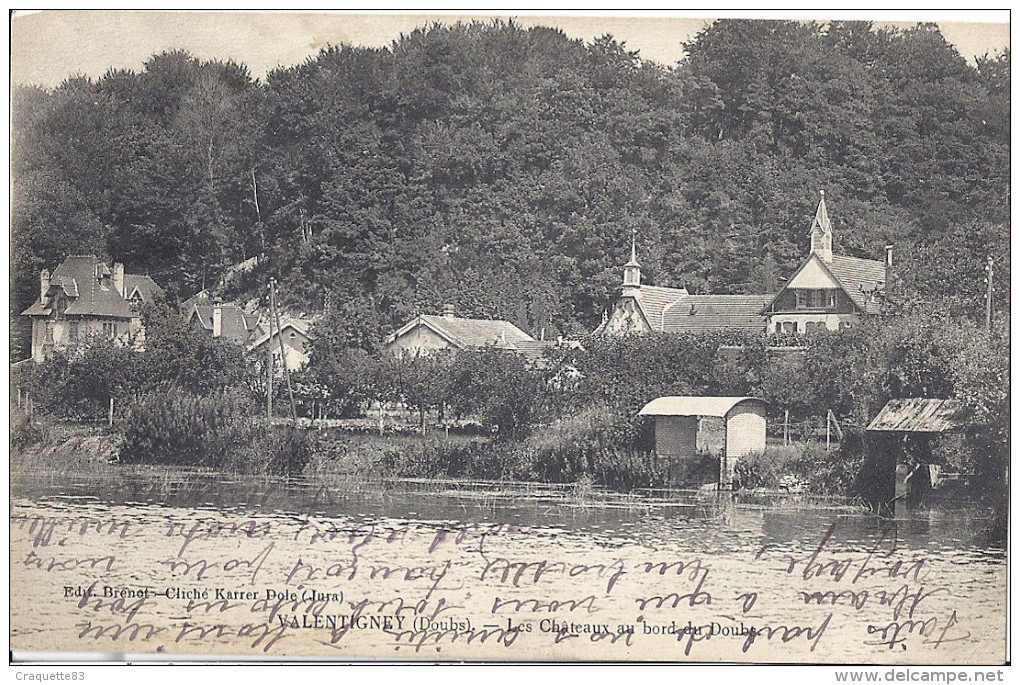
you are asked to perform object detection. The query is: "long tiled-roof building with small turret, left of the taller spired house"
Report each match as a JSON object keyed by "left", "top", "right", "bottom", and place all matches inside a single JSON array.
[{"left": 595, "top": 234, "right": 770, "bottom": 335}]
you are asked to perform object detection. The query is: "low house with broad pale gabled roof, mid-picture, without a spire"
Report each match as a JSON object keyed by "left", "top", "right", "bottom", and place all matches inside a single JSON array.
[{"left": 385, "top": 305, "right": 556, "bottom": 357}]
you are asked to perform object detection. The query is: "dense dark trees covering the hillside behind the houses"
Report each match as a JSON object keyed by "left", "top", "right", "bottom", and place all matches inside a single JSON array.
[{"left": 11, "top": 20, "right": 1010, "bottom": 358}]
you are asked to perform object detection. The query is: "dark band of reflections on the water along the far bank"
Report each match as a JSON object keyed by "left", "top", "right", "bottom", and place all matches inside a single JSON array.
[{"left": 17, "top": 467, "right": 1005, "bottom": 555}]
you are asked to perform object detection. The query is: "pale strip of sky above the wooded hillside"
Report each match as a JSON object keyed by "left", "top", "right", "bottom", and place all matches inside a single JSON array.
[{"left": 10, "top": 10, "right": 1010, "bottom": 87}]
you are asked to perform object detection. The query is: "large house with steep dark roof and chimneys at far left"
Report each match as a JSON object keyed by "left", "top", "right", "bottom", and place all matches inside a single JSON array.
[{"left": 21, "top": 255, "right": 163, "bottom": 362}]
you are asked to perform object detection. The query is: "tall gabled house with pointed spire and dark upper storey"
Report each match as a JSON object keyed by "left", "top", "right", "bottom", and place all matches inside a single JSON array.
[{"left": 761, "top": 192, "right": 893, "bottom": 333}]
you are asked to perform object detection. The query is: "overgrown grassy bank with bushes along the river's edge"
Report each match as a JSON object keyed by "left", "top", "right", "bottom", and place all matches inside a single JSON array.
[{"left": 11, "top": 398, "right": 859, "bottom": 495}]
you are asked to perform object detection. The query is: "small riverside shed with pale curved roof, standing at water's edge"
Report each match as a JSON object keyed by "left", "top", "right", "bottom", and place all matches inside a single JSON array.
[{"left": 639, "top": 396, "right": 767, "bottom": 485}]
